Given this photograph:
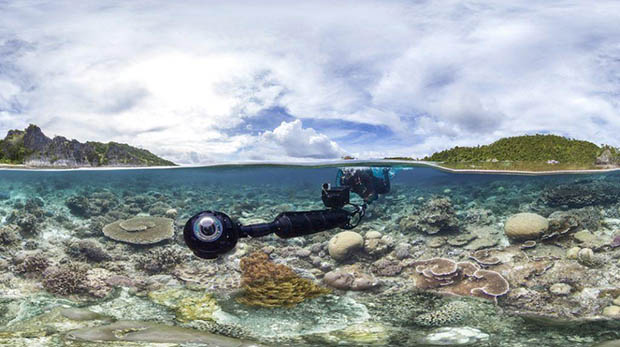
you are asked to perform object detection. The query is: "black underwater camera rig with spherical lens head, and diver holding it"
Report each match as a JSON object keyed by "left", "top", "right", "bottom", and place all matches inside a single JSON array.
[{"left": 183, "top": 167, "right": 393, "bottom": 259}]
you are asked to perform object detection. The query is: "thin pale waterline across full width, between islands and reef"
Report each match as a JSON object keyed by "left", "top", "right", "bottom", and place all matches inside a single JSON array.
[{"left": 0, "top": 159, "right": 620, "bottom": 176}]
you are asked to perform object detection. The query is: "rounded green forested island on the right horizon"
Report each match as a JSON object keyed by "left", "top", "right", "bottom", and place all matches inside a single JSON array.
[{"left": 424, "top": 135, "right": 620, "bottom": 171}]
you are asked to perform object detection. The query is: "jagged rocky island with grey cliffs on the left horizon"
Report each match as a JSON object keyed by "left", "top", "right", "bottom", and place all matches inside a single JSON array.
[{"left": 0, "top": 124, "right": 176, "bottom": 168}]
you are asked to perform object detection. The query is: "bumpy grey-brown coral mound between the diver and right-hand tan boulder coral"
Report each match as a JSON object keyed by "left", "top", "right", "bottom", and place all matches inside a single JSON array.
[{"left": 400, "top": 198, "right": 459, "bottom": 235}]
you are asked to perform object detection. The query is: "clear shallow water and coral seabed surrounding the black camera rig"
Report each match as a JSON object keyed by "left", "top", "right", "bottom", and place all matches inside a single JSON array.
[{"left": 0, "top": 163, "right": 620, "bottom": 346}]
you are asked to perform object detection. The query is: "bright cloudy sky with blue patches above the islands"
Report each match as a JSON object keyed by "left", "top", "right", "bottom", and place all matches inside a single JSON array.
[{"left": 0, "top": 0, "right": 620, "bottom": 164}]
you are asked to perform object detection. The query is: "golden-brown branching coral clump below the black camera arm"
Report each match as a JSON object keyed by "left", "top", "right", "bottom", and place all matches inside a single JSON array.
[{"left": 237, "top": 252, "right": 330, "bottom": 307}]
